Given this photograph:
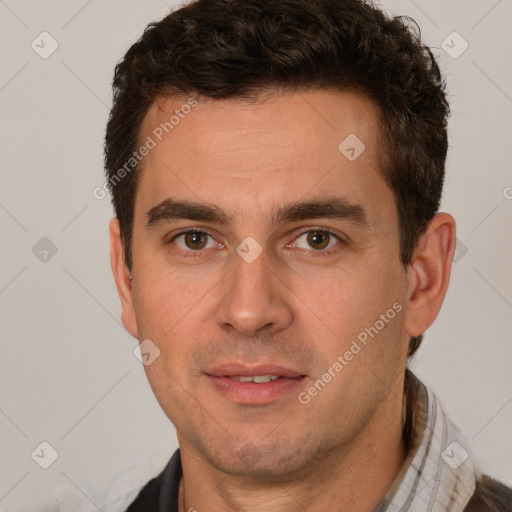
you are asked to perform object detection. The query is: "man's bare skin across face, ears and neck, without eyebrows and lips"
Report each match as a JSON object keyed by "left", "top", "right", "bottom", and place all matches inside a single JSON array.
[{"left": 110, "top": 90, "right": 455, "bottom": 512}]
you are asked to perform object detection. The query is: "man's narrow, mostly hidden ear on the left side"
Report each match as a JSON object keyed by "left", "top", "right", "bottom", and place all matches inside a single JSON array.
[{"left": 110, "top": 218, "right": 138, "bottom": 339}]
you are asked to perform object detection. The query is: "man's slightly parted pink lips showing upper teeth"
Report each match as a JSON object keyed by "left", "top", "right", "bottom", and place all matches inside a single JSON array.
[{"left": 205, "top": 364, "right": 306, "bottom": 405}]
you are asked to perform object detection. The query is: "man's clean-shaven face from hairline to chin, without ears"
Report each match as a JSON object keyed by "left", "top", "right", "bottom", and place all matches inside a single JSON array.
[{"left": 118, "top": 91, "right": 408, "bottom": 478}]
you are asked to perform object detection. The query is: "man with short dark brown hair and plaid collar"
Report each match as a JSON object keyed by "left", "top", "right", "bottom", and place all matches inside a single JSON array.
[{"left": 105, "top": 0, "right": 511, "bottom": 512}]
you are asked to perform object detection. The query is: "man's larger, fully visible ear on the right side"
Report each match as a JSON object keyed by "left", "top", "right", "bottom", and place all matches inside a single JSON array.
[{"left": 405, "top": 213, "right": 456, "bottom": 336}]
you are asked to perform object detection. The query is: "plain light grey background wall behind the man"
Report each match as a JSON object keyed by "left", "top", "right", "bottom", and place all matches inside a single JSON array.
[{"left": 0, "top": 0, "right": 512, "bottom": 512}]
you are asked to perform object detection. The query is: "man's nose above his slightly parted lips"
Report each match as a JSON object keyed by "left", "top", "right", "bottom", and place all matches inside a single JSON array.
[{"left": 216, "top": 252, "right": 293, "bottom": 337}]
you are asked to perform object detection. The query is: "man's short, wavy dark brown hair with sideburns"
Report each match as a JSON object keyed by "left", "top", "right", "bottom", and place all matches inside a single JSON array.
[{"left": 105, "top": 0, "right": 449, "bottom": 355}]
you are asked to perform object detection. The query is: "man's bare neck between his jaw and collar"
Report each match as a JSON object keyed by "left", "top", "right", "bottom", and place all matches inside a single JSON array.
[{"left": 178, "top": 384, "right": 406, "bottom": 512}]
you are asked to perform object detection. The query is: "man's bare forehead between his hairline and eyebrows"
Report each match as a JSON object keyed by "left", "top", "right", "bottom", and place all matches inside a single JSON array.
[{"left": 138, "top": 91, "right": 392, "bottom": 224}]
